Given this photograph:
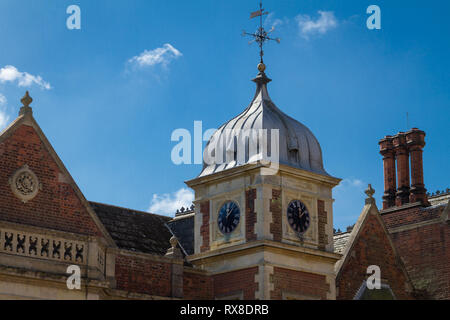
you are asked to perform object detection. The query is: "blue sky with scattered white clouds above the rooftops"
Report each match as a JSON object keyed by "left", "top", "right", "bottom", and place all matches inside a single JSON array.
[{"left": 0, "top": 0, "right": 450, "bottom": 228}]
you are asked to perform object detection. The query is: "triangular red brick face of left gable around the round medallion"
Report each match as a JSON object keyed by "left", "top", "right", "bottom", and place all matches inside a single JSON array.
[{"left": 0, "top": 125, "right": 102, "bottom": 236}]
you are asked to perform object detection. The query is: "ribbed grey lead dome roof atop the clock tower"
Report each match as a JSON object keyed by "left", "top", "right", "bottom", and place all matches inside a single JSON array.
[{"left": 199, "top": 71, "right": 328, "bottom": 177}]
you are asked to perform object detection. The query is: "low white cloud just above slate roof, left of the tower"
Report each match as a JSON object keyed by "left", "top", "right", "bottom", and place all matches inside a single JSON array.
[{"left": 148, "top": 188, "right": 194, "bottom": 216}]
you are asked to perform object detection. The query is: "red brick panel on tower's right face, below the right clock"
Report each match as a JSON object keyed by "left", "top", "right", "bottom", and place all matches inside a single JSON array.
[{"left": 270, "top": 267, "right": 330, "bottom": 300}]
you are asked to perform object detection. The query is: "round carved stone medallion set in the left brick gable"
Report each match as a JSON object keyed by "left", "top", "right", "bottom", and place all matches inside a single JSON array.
[{"left": 9, "top": 165, "right": 42, "bottom": 203}]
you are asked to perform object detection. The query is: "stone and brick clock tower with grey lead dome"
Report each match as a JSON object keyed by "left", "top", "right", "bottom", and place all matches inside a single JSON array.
[{"left": 186, "top": 63, "right": 340, "bottom": 299}]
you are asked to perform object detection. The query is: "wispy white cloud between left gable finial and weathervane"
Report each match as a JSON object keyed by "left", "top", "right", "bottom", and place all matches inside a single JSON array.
[{"left": 128, "top": 43, "right": 183, "bottom": 67}]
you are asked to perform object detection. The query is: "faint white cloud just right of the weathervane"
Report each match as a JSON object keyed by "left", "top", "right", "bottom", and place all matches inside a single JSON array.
[{"left": 296, "top": 11, "right": 338, "bottom": 39}]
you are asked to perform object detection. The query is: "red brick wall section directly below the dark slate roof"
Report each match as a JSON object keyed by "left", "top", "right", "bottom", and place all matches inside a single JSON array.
[{"left": 116, "top": 255, "right": 172, "bottom": 297}]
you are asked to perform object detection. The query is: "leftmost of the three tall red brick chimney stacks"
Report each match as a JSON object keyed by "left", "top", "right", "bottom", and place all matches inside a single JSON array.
[{"left": 379, "top": 136, "right": 397, "bottom": 209}]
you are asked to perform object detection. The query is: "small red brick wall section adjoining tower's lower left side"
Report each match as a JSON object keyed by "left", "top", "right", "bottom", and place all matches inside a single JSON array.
[{"left": 183, "top": 271, "right": 214, "bottom": 300}]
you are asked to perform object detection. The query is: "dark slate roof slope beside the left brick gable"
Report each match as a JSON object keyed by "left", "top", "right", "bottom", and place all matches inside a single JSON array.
[{"left": 90, "top": 202, "right": 172, "bottom": 255}]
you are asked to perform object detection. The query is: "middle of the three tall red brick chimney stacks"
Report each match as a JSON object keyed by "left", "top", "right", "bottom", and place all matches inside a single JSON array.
[{"left": 392, "top": 132, "right": 410, "bottom": 206}]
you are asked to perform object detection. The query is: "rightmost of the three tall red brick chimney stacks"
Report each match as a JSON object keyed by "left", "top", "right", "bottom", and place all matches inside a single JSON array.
[{"left": 406, "top": 128, "right": 428, "bottom": 204}]
